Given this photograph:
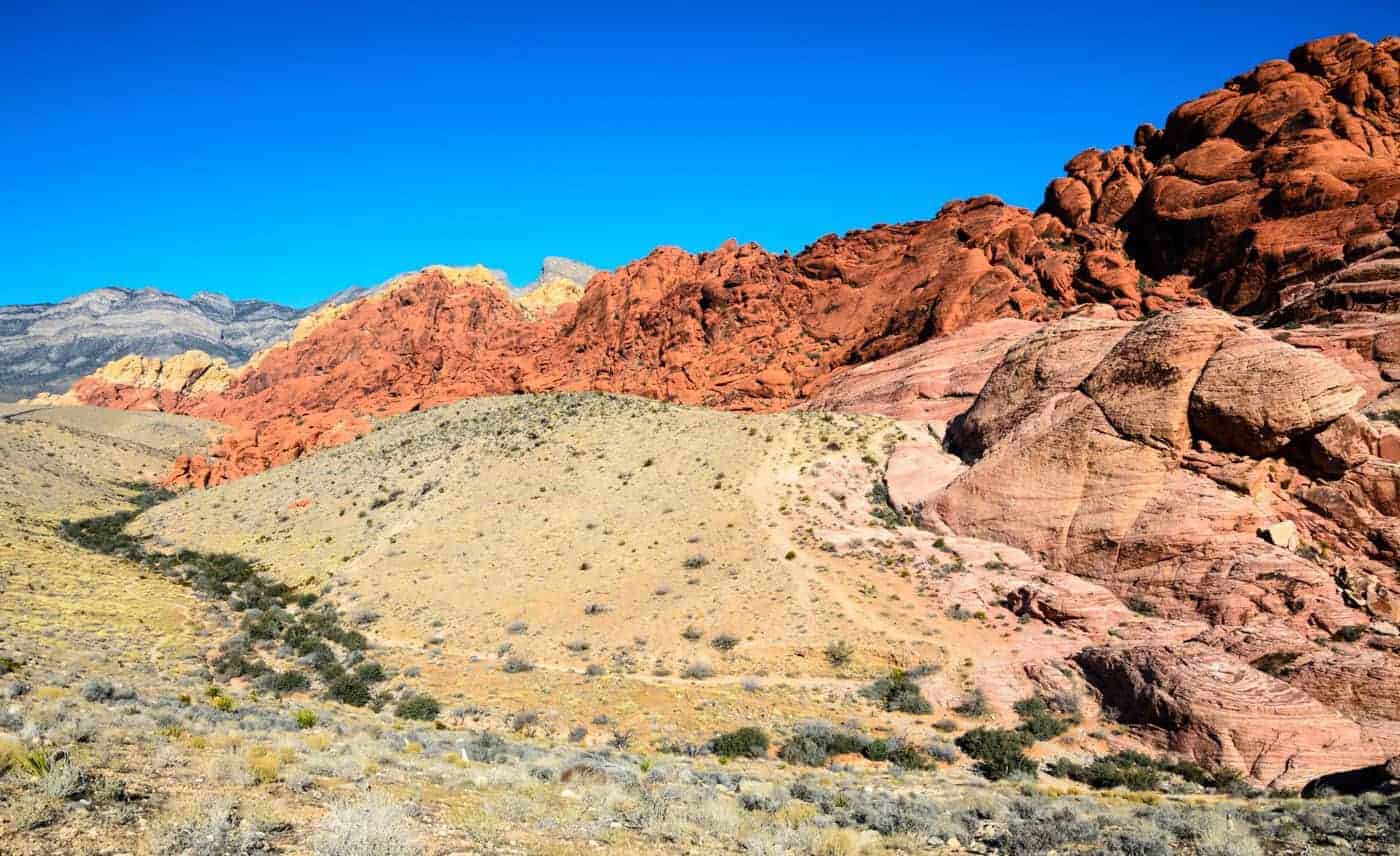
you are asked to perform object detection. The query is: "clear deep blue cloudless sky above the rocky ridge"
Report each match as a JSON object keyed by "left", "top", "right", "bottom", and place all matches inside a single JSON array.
[{"left": 0, "top": 0, "right": 1400, "bottom": 304}]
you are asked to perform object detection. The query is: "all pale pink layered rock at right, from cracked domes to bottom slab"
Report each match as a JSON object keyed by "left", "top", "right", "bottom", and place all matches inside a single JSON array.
[{"left": 912, "top": 310, "right": 1400, "bottom": 787}]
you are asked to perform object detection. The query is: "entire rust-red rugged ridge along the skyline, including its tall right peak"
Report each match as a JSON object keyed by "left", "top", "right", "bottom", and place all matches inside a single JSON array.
[{"left": 78, "top": 36, "right": 1400, "bottom": 495}]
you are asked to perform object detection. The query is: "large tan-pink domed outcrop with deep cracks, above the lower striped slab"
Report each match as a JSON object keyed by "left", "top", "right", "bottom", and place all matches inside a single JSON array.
[{"left": 921, "top": 310, "right": 1392, "bottom": 628}]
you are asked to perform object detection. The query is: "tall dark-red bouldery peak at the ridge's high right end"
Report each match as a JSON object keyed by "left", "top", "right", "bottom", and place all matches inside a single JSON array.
[{"left": 1042, "top": 35, "right": 1400, "bottom": 312}]
